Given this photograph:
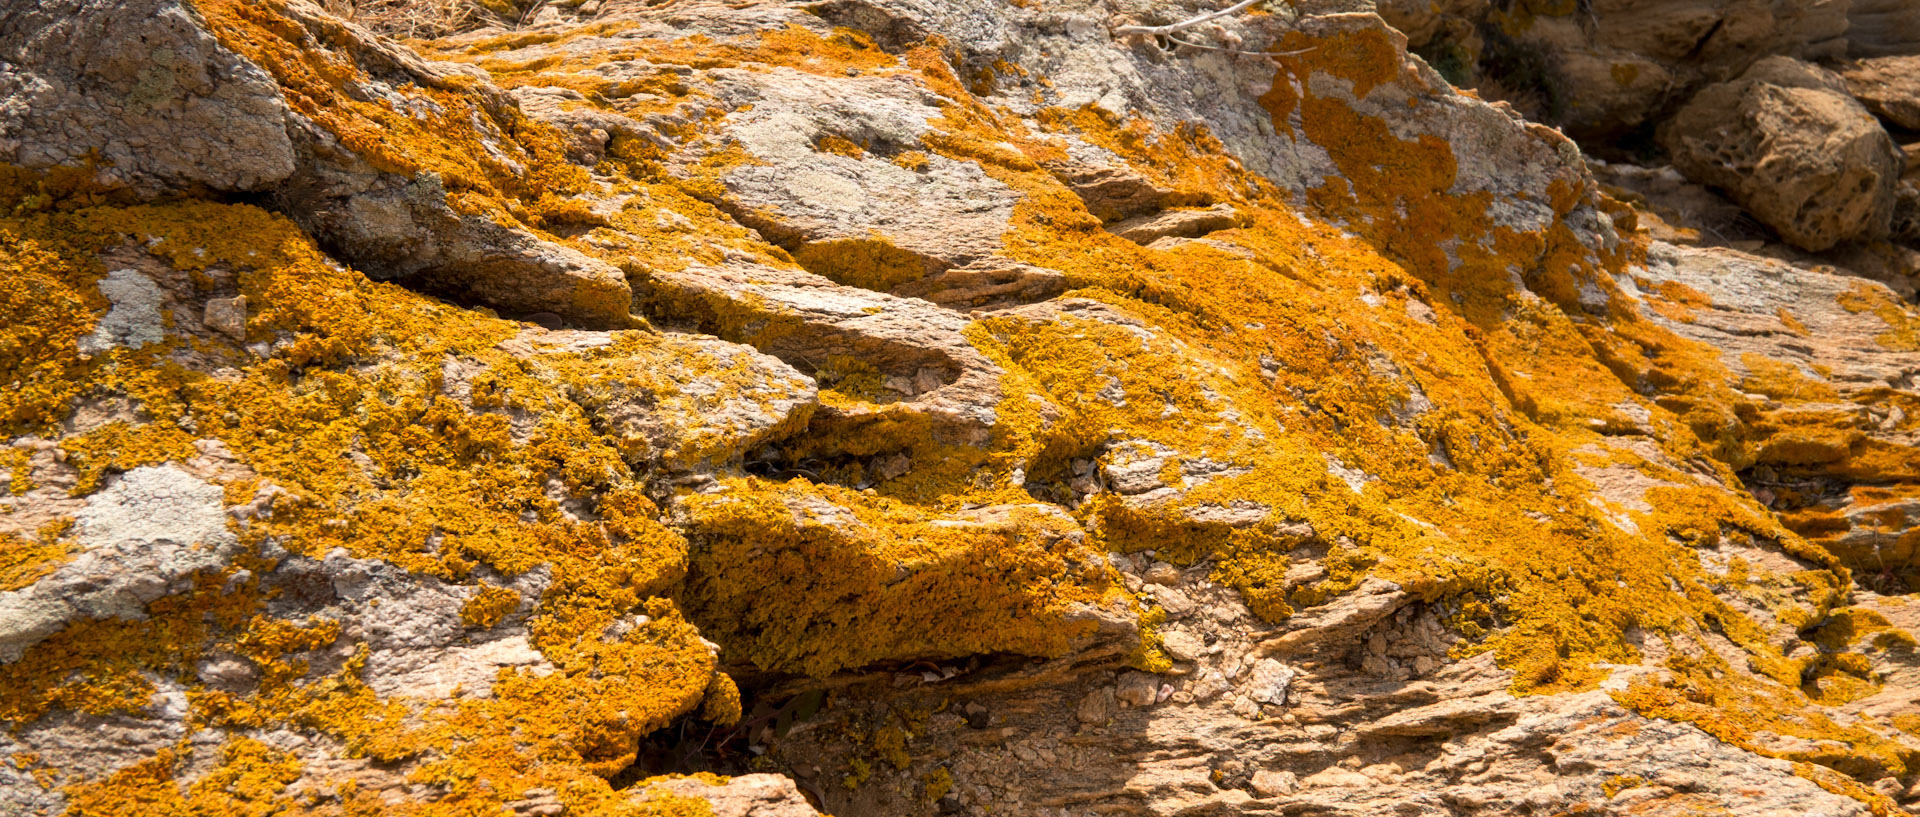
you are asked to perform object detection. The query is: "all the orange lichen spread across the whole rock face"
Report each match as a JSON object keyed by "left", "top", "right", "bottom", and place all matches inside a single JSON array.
[{"left": 0, "top": 0, "right": 1920, "bottom": 815}]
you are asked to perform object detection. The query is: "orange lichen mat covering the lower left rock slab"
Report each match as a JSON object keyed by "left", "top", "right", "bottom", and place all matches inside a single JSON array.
[{"left": 0, "top": 203, "right": 729, "bottom": 813}]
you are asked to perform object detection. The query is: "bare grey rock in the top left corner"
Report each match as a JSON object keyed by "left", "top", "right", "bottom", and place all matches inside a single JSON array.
[{"left": 0, "top": 0, "right": 294, "bottom": 198}]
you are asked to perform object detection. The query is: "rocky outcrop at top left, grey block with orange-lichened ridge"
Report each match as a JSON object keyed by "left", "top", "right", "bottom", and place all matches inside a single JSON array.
[{"left": 0, "top": 0, "right": 630, "bottom": 328}]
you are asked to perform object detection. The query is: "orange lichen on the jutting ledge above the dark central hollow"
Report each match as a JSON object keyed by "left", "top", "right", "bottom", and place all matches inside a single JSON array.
[{"left": 685, "top": 479, "right": 1098, "bottom": 675}]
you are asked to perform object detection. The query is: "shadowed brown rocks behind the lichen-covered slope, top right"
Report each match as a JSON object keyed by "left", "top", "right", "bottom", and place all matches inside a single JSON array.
[{"left": 1379, "top": 0, "right": 1920, "bottom": 258}]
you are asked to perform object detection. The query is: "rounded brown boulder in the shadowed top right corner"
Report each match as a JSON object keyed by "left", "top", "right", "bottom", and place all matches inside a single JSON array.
[{"left": 1661, "top": 58, "right": 1903, "bottom": 251}]
